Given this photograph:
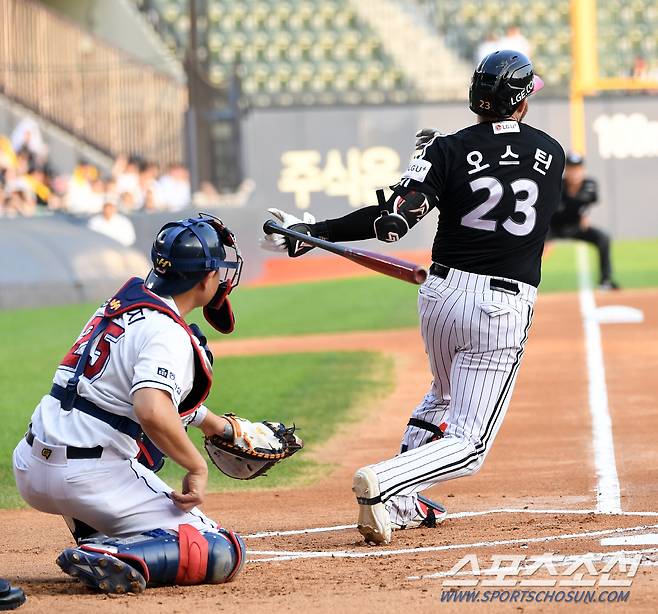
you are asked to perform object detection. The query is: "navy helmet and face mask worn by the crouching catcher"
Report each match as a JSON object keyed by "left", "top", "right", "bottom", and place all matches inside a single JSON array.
[{"left": 145, "top": 213, "right": 242, "bottom": 334}]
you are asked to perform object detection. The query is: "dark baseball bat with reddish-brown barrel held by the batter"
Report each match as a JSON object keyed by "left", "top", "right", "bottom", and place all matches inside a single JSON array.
[{"left": 263, "top": 220, "right": 427, "bottom": 285}]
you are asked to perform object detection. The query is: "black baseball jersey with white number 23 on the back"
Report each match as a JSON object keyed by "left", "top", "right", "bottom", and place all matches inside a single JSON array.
[{"left": 398, "top": 120, "right": 565, "bottom": 286}]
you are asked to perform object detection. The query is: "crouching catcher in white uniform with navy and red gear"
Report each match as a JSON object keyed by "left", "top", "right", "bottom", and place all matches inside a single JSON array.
[{"left": 13, "top": 214, "right": 303, "bottom": 593}]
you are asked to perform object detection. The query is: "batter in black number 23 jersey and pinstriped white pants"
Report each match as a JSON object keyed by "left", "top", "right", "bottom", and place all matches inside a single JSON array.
[{"left": 263, "top": 51, "right": 565, "bottom": 544}]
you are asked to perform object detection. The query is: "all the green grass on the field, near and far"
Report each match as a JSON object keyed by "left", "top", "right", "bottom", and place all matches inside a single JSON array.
[{"left": 0, "top": 240, "right": 658, "bottom": 506}]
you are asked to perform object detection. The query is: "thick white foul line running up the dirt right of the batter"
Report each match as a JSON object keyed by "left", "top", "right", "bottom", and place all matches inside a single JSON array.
[{"left": 576, "top": 243, "right": 621, "bottom": 514}]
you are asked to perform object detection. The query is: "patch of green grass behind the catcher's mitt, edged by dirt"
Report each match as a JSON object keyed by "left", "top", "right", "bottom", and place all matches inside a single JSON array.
[{"left": 161, "top": 352, "right": 392, "bottom": 490}]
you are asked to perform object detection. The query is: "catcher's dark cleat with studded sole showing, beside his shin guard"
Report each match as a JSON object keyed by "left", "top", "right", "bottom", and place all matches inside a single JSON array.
[{"left": 56, "top": 548, "right": 146, "bottom": 595}]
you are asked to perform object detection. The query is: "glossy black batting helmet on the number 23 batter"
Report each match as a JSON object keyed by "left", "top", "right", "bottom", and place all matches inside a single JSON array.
[{"left": 468, "top": 50, "right": 544, "bottom": 118}]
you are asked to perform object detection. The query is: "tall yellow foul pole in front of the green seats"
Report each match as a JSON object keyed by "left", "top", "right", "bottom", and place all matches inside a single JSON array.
[{"left": 569, "top": 0, "right": 599, "bottom": 154}]
